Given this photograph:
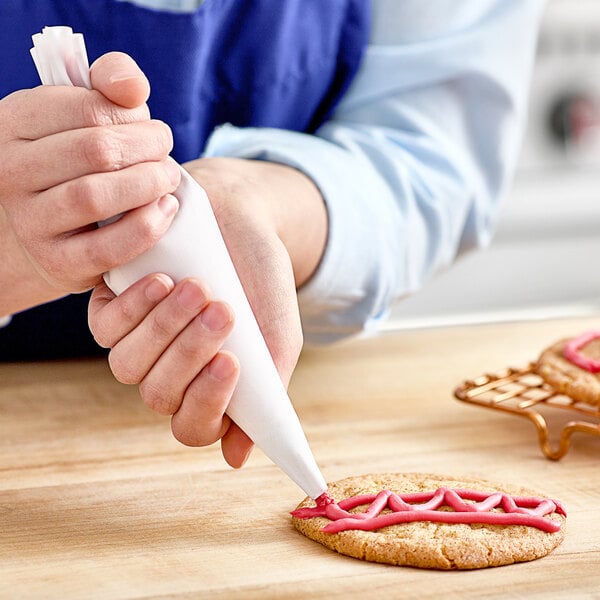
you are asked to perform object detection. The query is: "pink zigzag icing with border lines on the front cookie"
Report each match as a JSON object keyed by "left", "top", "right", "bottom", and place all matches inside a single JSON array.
[{"left": 292, "top": 488, "right": 566, "bottom": 533}]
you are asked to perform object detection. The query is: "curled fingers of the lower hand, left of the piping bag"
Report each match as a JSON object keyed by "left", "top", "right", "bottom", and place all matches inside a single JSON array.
[{"left": 89, "top": 274, "right": 252, "bottom": 467}]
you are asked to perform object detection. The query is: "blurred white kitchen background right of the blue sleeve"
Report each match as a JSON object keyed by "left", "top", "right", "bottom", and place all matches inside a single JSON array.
[{"left": 383, "top": 0, "right": 600, "bottom": 329}]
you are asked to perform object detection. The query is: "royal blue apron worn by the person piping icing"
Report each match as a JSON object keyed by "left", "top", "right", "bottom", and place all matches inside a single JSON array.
[{"left": 0, "top": 0, "right": 370, "bottom": 360}]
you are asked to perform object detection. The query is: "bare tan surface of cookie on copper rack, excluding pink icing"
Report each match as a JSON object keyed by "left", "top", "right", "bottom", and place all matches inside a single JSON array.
[{"left": 535, "top": 338, "right": 600, "bottom": 406}]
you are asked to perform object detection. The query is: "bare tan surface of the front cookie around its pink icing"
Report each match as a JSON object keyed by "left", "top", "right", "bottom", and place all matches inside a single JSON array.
[{"left": 292, "top": 473, "right": 565, "bottom": 569}]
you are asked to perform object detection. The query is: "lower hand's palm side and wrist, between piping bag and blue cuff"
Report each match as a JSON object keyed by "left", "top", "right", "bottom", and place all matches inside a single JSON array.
[{"left": 184, "top": 158, "right": 328, "bottom": 386}]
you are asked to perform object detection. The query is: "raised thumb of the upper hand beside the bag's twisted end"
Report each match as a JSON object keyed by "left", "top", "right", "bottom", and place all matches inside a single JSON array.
[{"left": 90, "top": 52, "right": 150, "bottom": 108}]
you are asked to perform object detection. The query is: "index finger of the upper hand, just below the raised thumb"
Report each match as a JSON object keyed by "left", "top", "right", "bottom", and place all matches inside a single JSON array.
[{"left": 0, "top": 85, "right": 150, "bottom": 140}]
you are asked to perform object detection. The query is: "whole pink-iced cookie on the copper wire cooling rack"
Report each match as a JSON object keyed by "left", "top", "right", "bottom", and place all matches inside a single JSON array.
[{"left": 535, "top": 330, "right": 600, "bottom": 406}]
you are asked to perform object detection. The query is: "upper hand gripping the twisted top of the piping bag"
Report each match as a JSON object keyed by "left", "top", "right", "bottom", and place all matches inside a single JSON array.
[{"left": 0, "top": 53, "right": 180, "bottom": 312}]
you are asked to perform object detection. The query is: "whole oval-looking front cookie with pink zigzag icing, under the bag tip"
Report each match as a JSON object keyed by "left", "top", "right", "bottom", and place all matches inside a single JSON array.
[{"left": 292, "top": 473, "right": 566, "bottom": 569}]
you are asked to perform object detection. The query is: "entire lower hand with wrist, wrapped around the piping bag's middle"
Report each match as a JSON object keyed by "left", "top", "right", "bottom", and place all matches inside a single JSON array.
[{"left": 89, "top": 159, "right": 327, "bottom": 467}]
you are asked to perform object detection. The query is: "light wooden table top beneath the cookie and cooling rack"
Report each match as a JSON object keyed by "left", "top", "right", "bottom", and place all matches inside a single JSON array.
[{"left": 0, "top": 315, "right": 600, "bottom": 599}]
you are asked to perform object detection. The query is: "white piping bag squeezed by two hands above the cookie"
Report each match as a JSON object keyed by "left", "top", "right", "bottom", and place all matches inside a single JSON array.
[{"left": 31, "top": 27, "right": 327, "bottom": 498}]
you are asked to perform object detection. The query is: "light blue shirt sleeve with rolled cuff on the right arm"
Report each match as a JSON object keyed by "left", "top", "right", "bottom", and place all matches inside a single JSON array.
[{"left": 206, "top": 0, "right": 544, "bottom": 343}]
